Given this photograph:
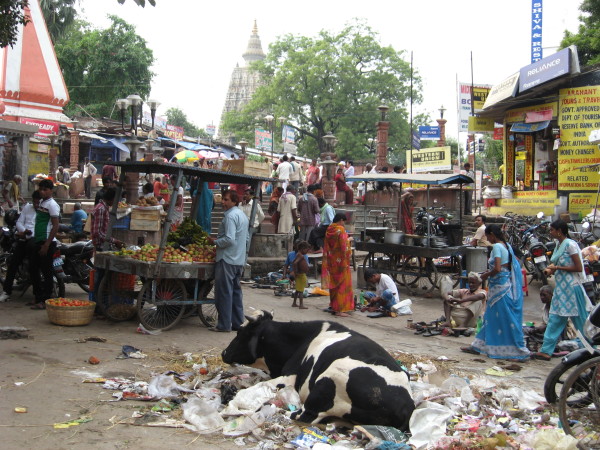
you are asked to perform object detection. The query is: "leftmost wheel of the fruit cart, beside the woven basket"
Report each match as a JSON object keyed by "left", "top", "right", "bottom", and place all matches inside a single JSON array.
[{"left": 95, "top": 271, "right": 140, "bottom": 322}]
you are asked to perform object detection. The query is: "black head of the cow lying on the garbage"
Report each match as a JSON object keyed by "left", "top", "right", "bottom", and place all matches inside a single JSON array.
[{"left": 221, "top": 311, "right": 273, "bottom": 365}]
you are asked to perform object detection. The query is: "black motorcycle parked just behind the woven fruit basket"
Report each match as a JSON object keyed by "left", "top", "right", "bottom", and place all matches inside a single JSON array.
[{"left": 53, "top": 241, "right": 94, "bottom": 292}]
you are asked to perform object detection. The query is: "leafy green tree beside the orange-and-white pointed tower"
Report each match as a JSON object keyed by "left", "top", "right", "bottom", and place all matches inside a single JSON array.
[{"left": 55, "top": 16, "right": 154, "bottom": 117}]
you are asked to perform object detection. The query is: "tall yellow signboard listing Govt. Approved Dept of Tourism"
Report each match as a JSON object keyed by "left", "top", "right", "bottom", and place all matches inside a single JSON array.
[{"left": 558, "top": 86, "right": 600, "bottom": 191}]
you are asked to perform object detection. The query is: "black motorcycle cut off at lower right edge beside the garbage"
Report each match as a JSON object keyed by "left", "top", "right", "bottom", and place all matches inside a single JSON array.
[{"left": 547, "top": 305, "right": 600, "bottom": 440}]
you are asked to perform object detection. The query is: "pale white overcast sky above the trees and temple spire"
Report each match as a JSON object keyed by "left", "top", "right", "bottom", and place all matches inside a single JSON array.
[{"left": 78, "top": 0, "right": 580, "bottom": 144}]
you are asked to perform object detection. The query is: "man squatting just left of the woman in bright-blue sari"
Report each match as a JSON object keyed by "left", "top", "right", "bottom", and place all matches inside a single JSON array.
[{"left": 440, "top": 272, "right": 487, "bottom": 328}]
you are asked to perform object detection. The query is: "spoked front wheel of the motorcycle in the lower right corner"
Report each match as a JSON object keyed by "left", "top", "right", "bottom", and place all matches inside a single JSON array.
[{"left": 558, "top": 357, "right": 600, "bottom": 440}]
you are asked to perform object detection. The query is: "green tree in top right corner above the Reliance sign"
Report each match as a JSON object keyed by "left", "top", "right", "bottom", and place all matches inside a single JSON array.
[{"left": 560, "top": 0, "right": 600, "bottom": 66}]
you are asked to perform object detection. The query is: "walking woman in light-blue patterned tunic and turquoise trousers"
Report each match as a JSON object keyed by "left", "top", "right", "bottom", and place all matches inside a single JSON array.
[{"left": 532, "top": 220, "right": 592, "bottom": 361}]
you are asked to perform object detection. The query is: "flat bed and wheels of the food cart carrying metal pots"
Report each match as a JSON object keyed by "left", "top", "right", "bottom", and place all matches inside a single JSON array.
[{"left": 356, "top": 242, "right": 466, "bottom": 295}]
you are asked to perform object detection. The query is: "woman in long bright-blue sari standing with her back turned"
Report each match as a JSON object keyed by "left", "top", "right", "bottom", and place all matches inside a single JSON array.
[{"left": 461, "top": 225, "right": 529, "bottom": 361}]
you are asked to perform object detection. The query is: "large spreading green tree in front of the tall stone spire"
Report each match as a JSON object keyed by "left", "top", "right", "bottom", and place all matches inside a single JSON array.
[{"left": 222, "top": 22, "right": 420, "bottom": 160}]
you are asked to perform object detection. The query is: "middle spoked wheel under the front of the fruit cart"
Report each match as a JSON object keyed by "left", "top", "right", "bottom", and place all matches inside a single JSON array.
[{"left": 137, "top": 279, "right": 187, "bottom": 331}]
